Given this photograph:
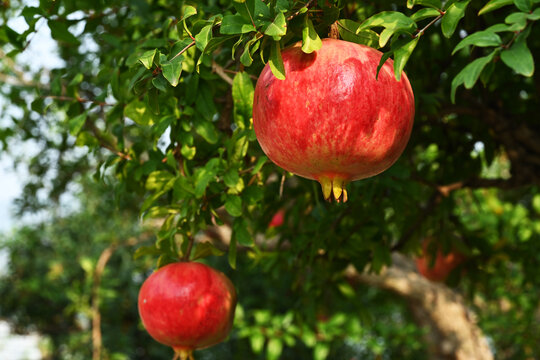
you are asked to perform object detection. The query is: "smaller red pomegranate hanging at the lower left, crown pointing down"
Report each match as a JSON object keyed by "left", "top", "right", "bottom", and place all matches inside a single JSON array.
[{"left": 139, "top": 262, "right": 236, "bottom": 360}]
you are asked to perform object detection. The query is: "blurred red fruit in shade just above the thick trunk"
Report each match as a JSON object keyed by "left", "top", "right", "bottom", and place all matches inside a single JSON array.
[{"left": 416, "top": 242, "right": 465, "bottom": 282}]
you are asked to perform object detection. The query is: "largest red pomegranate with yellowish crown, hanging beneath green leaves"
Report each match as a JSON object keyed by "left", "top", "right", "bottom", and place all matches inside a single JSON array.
[{"left": 253, "top": 39, "right": 414, "bottom": 201}]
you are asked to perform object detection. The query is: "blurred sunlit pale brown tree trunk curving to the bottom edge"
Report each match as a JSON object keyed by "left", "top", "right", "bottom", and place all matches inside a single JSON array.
[{"left": 346, "top": 254, "right": 493, "bottom": 360}]
